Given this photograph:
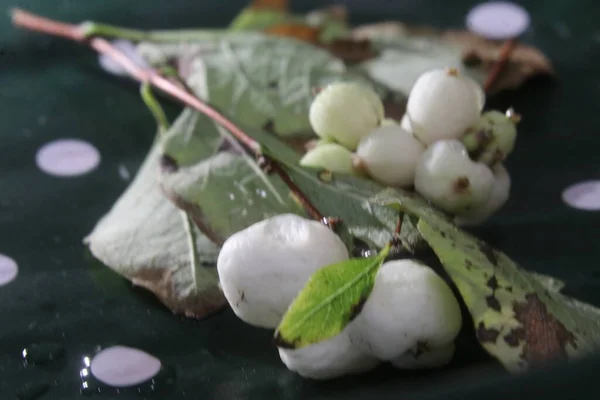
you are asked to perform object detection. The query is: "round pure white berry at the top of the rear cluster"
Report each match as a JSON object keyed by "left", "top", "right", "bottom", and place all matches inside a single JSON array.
[{"left": 404, "top": 68, "right": 482, "bottom": 145}]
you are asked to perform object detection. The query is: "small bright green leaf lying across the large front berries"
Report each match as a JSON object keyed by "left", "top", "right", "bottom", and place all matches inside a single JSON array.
[{"left": 275, "top": 246, "right": 390, "bottom": 349}]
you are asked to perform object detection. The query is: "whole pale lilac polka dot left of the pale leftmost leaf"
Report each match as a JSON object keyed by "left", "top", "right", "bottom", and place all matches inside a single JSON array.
[{"left": 35, "top": 139, "right": 100, "bottom": 176}]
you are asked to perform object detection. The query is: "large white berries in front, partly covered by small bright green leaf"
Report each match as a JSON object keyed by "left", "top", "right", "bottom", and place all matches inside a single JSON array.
[{"left": 217, "top": 214, "right": 462, "bottom": 379}]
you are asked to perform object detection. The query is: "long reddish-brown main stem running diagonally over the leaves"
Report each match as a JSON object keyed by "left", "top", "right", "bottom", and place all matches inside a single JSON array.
[{"left": 12, "top": 9, "right": 336, "bottom": 228}]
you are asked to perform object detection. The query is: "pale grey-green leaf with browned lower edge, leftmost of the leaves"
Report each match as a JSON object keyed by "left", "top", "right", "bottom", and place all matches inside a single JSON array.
[{"left": 84, "top": 133, "right": 226, "bottom": 318}]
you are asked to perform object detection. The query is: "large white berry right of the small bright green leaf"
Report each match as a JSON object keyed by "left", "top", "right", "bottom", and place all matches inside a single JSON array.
[{"left": 350, "top": 259, "right": 462, "bottom": 360}]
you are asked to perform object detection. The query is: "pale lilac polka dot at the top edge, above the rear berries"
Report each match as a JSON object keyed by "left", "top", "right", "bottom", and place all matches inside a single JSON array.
[{"left": 466, "top": 1, "right": 530, "bottom": 40}]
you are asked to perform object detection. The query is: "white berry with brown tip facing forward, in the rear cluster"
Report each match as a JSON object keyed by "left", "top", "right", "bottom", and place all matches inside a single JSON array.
[{"left": 415, "top": 140, "right": 494, "bottom": 213}]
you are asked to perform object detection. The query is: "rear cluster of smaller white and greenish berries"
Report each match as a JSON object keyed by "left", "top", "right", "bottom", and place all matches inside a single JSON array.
[{"left": 300, "top": 68, "right": 518, "bottom": 225}]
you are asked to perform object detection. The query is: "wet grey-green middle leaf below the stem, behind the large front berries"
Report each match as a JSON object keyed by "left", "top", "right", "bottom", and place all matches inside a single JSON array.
[{"left": 158, "top": 112, "right": 304, "bottom": 245}]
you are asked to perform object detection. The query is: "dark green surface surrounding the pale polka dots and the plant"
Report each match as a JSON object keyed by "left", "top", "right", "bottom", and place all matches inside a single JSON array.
[{"left": 0, "top": 0, "right": 600, "bottom": 400}]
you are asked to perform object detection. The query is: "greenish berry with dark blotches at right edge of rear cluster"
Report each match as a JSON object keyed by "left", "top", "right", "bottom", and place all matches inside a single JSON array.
[{"left": 462, "top": 110, "right": 520, "bottom": 165}]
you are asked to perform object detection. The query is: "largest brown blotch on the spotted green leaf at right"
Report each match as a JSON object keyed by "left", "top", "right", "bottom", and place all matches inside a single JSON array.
[{"left": 514, "top": 293, "right": 577, "bottom": 365}]
